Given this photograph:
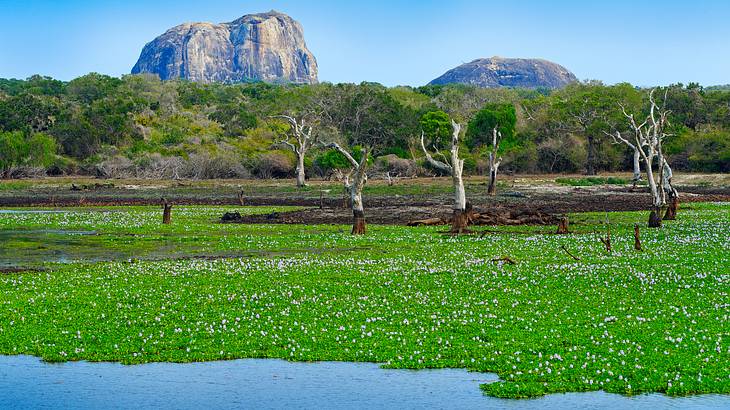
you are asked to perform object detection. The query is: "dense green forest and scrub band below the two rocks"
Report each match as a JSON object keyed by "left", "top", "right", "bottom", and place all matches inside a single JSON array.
[{"left": 0, "top": 73, "right": 730, "bottom": 178}]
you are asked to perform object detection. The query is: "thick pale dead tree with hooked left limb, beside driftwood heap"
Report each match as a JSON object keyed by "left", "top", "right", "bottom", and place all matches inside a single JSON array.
[{"left": 421, "top": 120, "right": 469, "bottom": 234}]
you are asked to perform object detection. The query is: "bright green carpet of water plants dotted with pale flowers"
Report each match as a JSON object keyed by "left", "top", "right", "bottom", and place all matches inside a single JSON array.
[{"left": 0, "top": 203, "right": 730, "bottom": 398}]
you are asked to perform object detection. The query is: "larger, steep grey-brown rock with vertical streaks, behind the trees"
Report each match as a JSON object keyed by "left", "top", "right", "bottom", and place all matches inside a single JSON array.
[{"left": 132, "top": 11, "right": 317, "bottom": 84}]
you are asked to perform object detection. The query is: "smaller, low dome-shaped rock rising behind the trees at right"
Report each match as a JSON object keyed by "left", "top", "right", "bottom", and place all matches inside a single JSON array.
[{"left": 429, "top": 57, "right": 578, "bottom": 88}]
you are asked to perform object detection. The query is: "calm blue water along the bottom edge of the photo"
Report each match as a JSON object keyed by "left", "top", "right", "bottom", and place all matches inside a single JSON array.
[{"left": 0, "top": 356, "right": 730, "bottom": 410}]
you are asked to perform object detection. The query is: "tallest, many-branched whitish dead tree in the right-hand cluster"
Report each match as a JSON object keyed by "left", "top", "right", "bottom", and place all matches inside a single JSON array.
[{"left": 611, "top": 90, "right": 671, "bottom": 228}]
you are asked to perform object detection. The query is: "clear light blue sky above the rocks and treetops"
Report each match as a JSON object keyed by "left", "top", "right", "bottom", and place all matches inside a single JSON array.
[{"left": 0, "top": 0, "right": 730, "bottom": 86}]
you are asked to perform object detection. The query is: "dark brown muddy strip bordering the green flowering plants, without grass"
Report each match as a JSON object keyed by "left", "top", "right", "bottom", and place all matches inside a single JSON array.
[{"left": 0, "top": 186, "right": 730, "bottom": 225}]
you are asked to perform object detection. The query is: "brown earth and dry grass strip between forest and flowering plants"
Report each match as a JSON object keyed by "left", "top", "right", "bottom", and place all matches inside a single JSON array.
[{"left": 0, "top": 174, "right": 730, "bottom": 225}]
